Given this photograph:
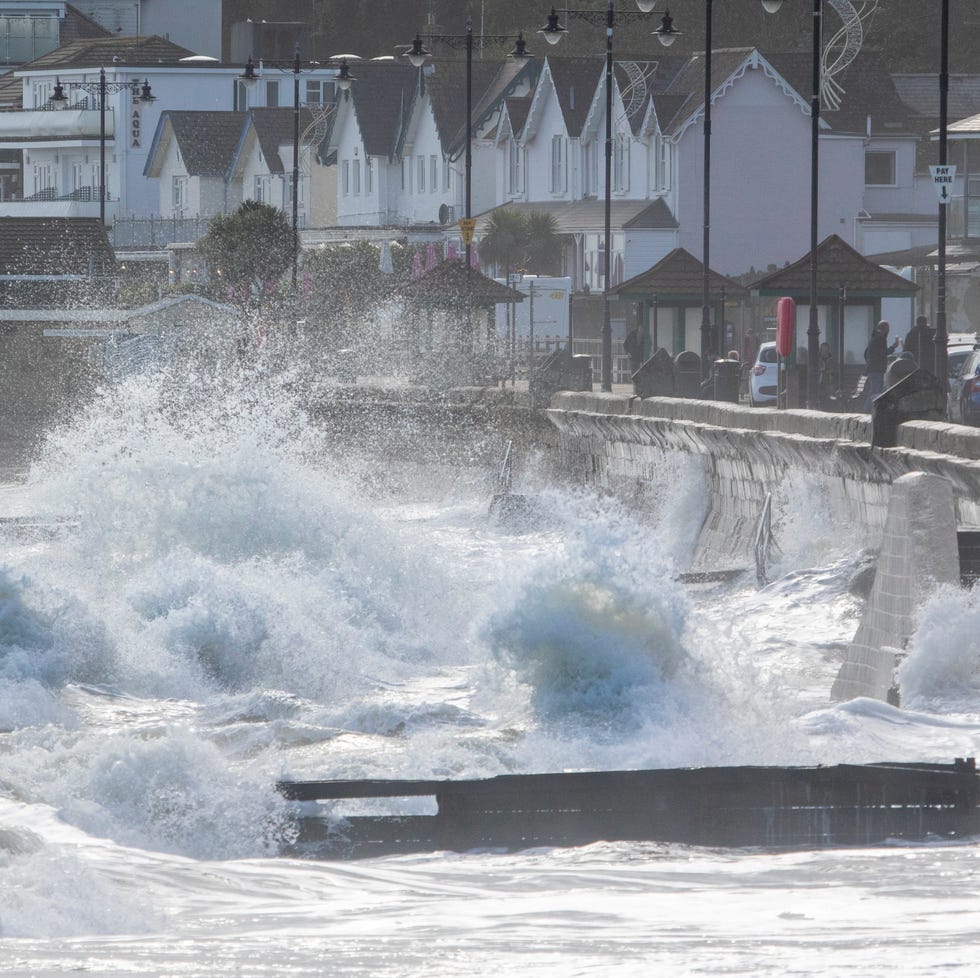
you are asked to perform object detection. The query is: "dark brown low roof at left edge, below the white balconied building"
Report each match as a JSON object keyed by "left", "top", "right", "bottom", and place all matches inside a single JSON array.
[{"left": 0, "top": 217, "right": 116, "bottom": 275}]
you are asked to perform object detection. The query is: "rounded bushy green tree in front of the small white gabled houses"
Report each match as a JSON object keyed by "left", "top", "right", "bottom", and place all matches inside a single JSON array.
[{"left": 198, "top": 200, "right": 293, "bottom": 310}]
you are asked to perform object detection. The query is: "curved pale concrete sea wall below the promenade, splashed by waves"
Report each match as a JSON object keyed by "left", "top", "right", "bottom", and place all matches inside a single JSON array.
[{"left": 548, "top": 392, "right": 980, "bottom": 570}]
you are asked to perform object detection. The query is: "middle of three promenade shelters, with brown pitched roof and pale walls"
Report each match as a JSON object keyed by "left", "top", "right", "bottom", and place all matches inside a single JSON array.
[{"left": 609, "top": 248, "right": 749, "bottom": 359}]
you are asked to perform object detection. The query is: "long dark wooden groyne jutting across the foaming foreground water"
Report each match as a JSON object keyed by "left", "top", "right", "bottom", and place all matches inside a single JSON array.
[{"left": 277, "top": 757, "right": 980, "bottom": 858}]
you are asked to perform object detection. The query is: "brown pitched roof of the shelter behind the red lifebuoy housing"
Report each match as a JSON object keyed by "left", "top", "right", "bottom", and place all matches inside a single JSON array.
[{"left": 749, "top": 234, "right": 919, "bottom": 299}]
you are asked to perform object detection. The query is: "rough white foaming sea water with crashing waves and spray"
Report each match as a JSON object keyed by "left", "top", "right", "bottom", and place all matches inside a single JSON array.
[{"left": 0, "top": 375, "right": 980, "bottom": 978}]
